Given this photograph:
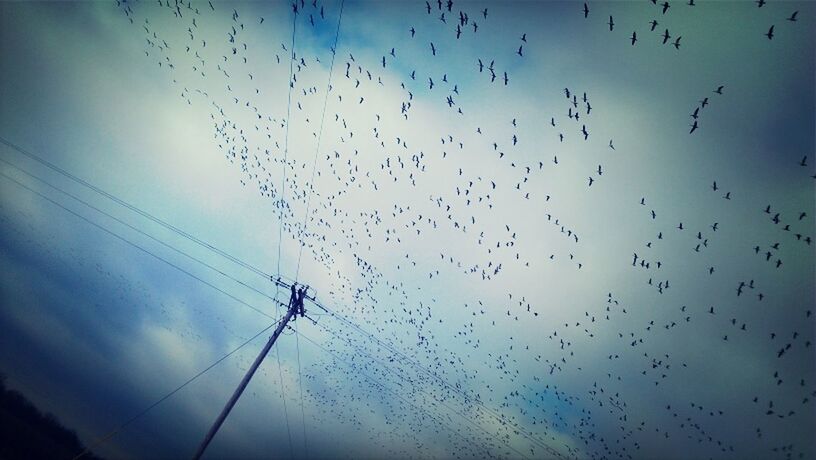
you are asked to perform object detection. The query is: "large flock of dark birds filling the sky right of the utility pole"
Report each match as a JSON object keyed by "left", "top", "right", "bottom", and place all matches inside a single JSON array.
[{"left": 49, "top": 0, "right": 816, "bottom": 458}]
